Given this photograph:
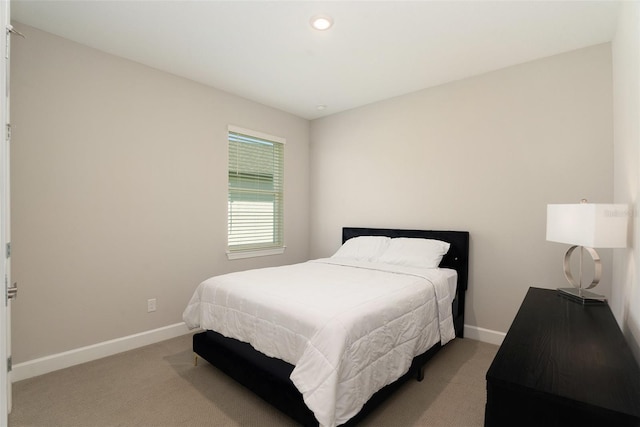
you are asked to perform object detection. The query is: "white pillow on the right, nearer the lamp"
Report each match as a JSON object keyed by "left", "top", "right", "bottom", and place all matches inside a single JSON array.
[{"left": 378, "top": 237, "right": 451, "bottom": 268}]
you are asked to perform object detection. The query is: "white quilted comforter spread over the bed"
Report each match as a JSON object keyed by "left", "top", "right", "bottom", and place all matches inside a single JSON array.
[{"left": 183, "top": 258, "right": 455, "bottom": 426}]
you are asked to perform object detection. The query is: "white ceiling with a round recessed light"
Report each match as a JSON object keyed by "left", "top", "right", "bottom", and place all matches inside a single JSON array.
[{"left": 11, "top": 0, "right": 618, "bottom": 119}]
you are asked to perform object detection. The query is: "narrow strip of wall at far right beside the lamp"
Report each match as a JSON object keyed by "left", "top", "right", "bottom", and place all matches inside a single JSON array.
[{"left": 610, "top": 2, "right": 640, "bottom": 361}]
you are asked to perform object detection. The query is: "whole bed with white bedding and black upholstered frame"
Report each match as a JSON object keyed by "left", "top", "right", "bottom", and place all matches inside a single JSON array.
[{"left": 183, "top": 227, "right": 469, "bottom": 426}]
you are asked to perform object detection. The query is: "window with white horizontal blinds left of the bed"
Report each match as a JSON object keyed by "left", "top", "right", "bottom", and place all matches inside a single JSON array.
[{"left": 228, "top": 126, "right": 285, "bottom": 259}]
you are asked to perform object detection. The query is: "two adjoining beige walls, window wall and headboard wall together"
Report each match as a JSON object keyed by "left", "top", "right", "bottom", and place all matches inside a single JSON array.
[{"left": 12, "top": 24, "right": 624, "bottom": 363}]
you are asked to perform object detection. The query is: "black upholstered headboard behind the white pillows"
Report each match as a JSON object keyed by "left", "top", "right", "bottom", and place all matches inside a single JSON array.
[{"left": 342, "top": 227, "right": 469, "bottom": 337}]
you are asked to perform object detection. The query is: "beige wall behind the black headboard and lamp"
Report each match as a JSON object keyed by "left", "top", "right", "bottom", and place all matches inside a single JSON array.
[{"left": 311, "top": 44, "right": 613, "bottom": 332}]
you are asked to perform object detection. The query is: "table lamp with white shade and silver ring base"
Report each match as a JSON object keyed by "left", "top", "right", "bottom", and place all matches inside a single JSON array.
[{"left": 547, "top": 199, "right": 629, "bottom": 304}]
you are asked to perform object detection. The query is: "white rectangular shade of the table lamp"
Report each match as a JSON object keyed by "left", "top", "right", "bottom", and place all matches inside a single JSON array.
[{"left": 547, "top": 203, "right": 629, "bottom": 248}]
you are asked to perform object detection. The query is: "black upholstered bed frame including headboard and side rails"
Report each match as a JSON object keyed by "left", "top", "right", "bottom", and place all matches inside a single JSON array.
[{"left": 193, "top": 227, "right": 469, "bottom": 426}]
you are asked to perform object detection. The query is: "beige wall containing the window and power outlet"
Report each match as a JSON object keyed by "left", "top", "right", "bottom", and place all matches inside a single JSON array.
[{"left": 11, "top": 23, "right": 309, "bottom": 363}]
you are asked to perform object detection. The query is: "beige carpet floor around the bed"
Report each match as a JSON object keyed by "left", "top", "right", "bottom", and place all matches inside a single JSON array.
[{"left": 9, "top": 335, "right": 498, "bottom": 427}]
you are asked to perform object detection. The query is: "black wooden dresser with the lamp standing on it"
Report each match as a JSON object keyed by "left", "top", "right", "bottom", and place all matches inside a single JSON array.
[{"left": 485, "top": 288, "right": 640, "bottom": 427}]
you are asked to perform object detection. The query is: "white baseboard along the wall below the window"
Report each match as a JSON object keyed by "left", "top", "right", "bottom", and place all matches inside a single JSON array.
[{"left": 10, "top": 322, "right": 189, "bottom": 382}]
